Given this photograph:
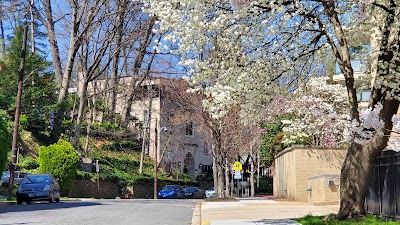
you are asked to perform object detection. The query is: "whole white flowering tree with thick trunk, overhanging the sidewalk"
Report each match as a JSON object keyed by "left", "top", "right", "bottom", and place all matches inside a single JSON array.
[{"left": 144, "top": 0, "right": 400, "bottom": 219}]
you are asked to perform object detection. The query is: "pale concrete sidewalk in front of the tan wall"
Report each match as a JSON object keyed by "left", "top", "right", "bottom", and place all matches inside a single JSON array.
[{"left": 201, "top": 197, "right": 339, "bottom": 225}]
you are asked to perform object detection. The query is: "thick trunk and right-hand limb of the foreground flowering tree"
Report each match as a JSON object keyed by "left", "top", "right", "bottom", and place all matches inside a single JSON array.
[{"left": 337, "top": 1, "right": 400, "bottom": 219}]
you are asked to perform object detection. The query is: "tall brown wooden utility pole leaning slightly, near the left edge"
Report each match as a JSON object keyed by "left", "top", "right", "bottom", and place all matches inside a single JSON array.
[{"left": 8, "top": 25, "right": 28, "bottom": 199}]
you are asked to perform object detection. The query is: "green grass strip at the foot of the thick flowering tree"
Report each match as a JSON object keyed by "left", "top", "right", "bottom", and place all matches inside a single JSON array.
[{"left": 294, "top": 214, "right": 400, "bottom": 225}]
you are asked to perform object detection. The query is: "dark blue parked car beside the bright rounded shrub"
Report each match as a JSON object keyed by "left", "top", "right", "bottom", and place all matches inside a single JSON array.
[{"left": 17, "top": 174, "right": 61, "bottom": 205}]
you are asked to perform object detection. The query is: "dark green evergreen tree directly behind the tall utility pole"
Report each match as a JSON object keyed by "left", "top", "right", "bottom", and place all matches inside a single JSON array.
[{"left": 0, "top": 27, "right": 56, "bottom": 133}]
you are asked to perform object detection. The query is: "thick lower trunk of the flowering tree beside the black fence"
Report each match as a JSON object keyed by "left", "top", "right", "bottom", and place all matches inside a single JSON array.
[{"left": 337, "top": 100, "right": 399, "bottom": 219}]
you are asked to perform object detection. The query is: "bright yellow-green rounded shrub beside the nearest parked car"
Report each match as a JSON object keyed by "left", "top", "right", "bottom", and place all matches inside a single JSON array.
[{"left": 39, "top": 139, "right": 79, "bottom": 194}]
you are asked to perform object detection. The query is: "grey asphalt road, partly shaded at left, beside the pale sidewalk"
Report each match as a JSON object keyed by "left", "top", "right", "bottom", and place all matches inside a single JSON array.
[{"left": 0, "top": 199, "right": 200, "bottom": 225}]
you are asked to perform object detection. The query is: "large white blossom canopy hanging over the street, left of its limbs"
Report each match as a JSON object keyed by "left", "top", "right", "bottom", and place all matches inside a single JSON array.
[{"left": 144, "top": 0, "right": 340, "bottom": 119}]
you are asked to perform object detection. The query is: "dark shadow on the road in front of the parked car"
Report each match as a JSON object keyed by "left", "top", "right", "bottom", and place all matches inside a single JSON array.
[{"left": 0, "top": 201, "right": 101, "bottom": 214}]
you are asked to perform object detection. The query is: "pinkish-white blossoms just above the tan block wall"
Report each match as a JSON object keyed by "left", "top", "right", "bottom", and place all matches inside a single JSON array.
[{"left": 281, "top": 78, "right": 350, "bottom": 146}]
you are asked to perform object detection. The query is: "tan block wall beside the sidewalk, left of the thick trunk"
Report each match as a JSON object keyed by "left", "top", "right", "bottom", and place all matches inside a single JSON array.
[{"left": 274, "top": 146, "right": 347, "bottom": 202}]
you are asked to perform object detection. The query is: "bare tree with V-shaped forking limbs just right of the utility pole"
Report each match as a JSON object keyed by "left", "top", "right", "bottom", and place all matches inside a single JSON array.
[{"left": 27, "top": 0, "right": 109, "bottom": 137}]
